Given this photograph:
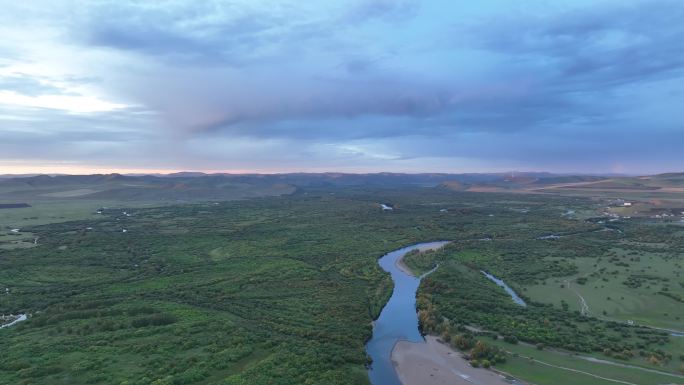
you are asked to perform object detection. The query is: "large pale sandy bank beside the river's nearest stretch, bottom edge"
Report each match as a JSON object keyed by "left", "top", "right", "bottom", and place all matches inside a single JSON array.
[{"left": 392, "top": 336, "right": 515, "bottom": 385}]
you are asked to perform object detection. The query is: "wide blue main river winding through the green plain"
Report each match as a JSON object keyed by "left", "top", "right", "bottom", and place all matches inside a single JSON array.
[{"left": 366, "top": 241, "right": 448, "bottom": 385}]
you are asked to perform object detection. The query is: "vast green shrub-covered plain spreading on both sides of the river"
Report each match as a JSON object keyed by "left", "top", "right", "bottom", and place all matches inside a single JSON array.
[{"left": 0, "top": 178, "right": 684, "bottom": 385}]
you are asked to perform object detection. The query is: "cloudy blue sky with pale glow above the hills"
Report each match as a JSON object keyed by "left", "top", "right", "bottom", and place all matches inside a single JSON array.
[{"left": 0, "top": 0, "right": 684, "bottom": 174}]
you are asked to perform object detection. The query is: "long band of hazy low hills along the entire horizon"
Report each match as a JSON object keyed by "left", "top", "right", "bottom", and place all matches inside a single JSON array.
[{"left": 0, "top": 172, "right": 684, "bottom": 203}]
